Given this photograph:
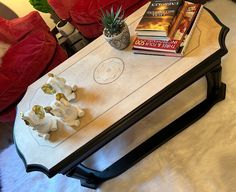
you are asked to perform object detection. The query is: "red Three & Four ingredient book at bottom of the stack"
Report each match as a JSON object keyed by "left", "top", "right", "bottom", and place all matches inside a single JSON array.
[{"left": 133, "top": 3, "right": 202, "bottom": 56}]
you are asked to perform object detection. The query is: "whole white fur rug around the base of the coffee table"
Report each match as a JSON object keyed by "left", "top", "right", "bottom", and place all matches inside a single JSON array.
[{"left": 0, "top": 0, "right": 236, "bottom": 192}]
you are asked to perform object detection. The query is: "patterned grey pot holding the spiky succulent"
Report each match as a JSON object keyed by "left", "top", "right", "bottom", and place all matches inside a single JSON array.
[{"left": 103, "top": 23, "right": 130, "bottom": 50}]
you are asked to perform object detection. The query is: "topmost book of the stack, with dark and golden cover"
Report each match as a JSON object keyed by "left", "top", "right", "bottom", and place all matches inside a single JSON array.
[{"left": 136, "top": 0, "right": 182, "bottom": 36}]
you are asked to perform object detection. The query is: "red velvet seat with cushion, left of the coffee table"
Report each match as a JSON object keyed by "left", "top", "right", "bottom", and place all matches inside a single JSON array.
[{"left": 0, "top": 12, "right": 67, "bottom": 122}]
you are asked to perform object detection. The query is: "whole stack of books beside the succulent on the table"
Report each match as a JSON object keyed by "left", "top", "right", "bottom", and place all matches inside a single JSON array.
[{"left": 133, "top": 0, "right": 202, "bottom": 56}]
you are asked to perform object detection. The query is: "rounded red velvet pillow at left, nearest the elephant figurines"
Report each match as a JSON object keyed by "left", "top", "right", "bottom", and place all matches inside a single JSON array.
[{"left": 0, "top": 30, "right": 56, "bottom": 112}]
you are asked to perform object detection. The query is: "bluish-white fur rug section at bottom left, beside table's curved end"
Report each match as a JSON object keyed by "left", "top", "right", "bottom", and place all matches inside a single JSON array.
[{"left": 0, "top": 145, "right": 92, "bottom": 192}]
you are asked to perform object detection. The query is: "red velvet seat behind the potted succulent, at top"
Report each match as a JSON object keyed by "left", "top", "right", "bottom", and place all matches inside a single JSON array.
[{"left": 48, "top": 0, "right": 148, "bottom": 38}]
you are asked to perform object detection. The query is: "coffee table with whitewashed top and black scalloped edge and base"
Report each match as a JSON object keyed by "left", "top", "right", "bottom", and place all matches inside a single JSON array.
[{"left": 14, "top": 5, "right": 229, "bottom": 188}]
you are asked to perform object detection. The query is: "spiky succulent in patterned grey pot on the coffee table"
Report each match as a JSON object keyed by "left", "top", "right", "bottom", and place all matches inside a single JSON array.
[{"left": 101, "top": 7, "right": 130, "bottom": 49}]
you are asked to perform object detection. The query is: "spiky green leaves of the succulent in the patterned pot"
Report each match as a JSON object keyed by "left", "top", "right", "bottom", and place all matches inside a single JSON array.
[{"left": 101, "top": 7, "right": 125, "bottom": 37}]
